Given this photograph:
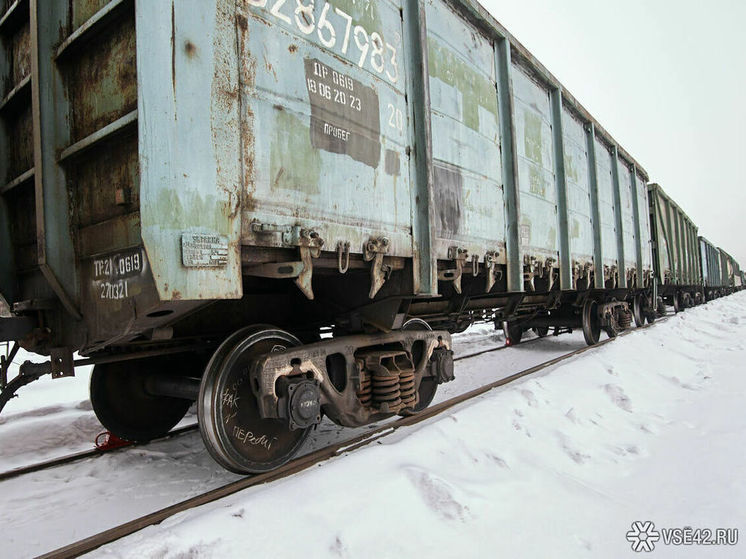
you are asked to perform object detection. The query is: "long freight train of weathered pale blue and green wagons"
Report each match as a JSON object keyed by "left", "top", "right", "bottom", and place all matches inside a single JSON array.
[{"left": 0, "top": 0, "right": 743, "bottom": 473}]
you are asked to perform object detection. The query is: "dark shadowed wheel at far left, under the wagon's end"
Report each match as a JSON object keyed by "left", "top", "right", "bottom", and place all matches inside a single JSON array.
[{"left": 91, "top": 356, "right": 196, "bottom": 442}]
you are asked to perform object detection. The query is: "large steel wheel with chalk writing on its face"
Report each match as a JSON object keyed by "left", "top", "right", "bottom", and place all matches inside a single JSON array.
[{"left": 197, "top": 326, "right": 311, "bottom": 474}]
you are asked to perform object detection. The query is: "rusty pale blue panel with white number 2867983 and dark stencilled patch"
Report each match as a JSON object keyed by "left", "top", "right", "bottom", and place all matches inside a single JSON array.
[{"left": 238, "top": 0, "right": 414, "bottom": 278}]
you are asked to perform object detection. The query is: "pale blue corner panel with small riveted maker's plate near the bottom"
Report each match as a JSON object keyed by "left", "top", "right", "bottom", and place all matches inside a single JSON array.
[{"left": 135, "top": 0, "right": 243, "bottom": 306}]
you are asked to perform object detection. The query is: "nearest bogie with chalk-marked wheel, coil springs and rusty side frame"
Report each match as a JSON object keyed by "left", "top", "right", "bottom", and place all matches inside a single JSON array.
[{"left": 198, "top": 321, "right": 453, "bottom": 473}]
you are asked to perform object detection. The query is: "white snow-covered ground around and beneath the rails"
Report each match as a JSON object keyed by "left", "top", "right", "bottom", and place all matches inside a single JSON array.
[{"left": 0, "top": 293, "right": 746, "bottom": 557}]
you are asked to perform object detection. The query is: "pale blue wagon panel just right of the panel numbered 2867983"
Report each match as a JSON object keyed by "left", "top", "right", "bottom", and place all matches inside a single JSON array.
[{"left": 426, "top": 0, "right": 505, "bottom": 263}]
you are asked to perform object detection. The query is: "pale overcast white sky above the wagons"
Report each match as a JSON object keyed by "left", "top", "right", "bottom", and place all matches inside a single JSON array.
[{"left": 480, "top": 0, "right": 746, "bottom": 266}]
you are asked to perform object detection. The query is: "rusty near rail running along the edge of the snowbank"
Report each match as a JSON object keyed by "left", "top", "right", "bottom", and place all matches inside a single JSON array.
[{"left": 40, "top": 317, "right": 667, "bottom": 559}]
